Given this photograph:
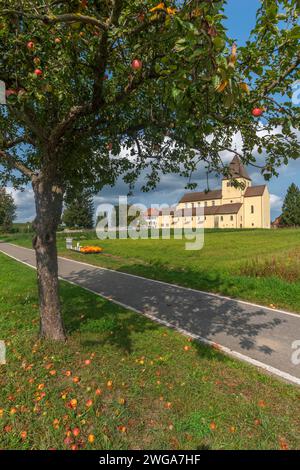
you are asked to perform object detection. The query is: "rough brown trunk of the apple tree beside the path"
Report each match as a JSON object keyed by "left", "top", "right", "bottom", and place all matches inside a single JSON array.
[{"left": 32, "top": 179, "right": 66, "bottom": 341}]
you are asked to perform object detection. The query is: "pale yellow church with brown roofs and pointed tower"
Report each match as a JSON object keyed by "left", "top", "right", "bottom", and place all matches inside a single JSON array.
[{"left": 158, "top": 156, "right": 270, "bottom": 229}]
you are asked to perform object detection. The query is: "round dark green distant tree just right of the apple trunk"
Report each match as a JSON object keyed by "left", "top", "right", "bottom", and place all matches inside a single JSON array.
[{"left": 62, "top": 191, "right": 94, "bottom": 229}]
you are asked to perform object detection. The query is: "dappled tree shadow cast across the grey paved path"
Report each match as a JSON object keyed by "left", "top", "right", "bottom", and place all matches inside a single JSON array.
[{"left": 59, "top": 264, "right": 286, "bottom": 356}]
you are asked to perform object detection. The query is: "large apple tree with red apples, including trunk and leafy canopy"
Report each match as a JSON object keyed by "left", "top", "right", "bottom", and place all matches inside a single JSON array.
[{"left": 0, "top": 0, "right": 300, "bottom": 340}]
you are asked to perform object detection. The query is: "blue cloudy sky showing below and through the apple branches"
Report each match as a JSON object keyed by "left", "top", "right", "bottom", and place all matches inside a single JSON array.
[{"left": 9, "top": 0, "right": 300, "bottom": 222}]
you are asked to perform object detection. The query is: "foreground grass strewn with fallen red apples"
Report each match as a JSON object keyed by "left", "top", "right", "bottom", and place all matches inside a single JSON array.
[{"left": 0, "top": 252, "right": 300, "bottom": 449}]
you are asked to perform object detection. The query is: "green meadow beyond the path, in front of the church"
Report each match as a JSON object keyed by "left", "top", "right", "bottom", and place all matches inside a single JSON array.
[{"left": 2, "top": 229, "right": 300, "bottom": 312}]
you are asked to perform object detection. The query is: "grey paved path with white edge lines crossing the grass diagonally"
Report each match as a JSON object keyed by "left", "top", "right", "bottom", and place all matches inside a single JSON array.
[{"left": 0, "top": 243, "right": 300, "bottom": 385}]
